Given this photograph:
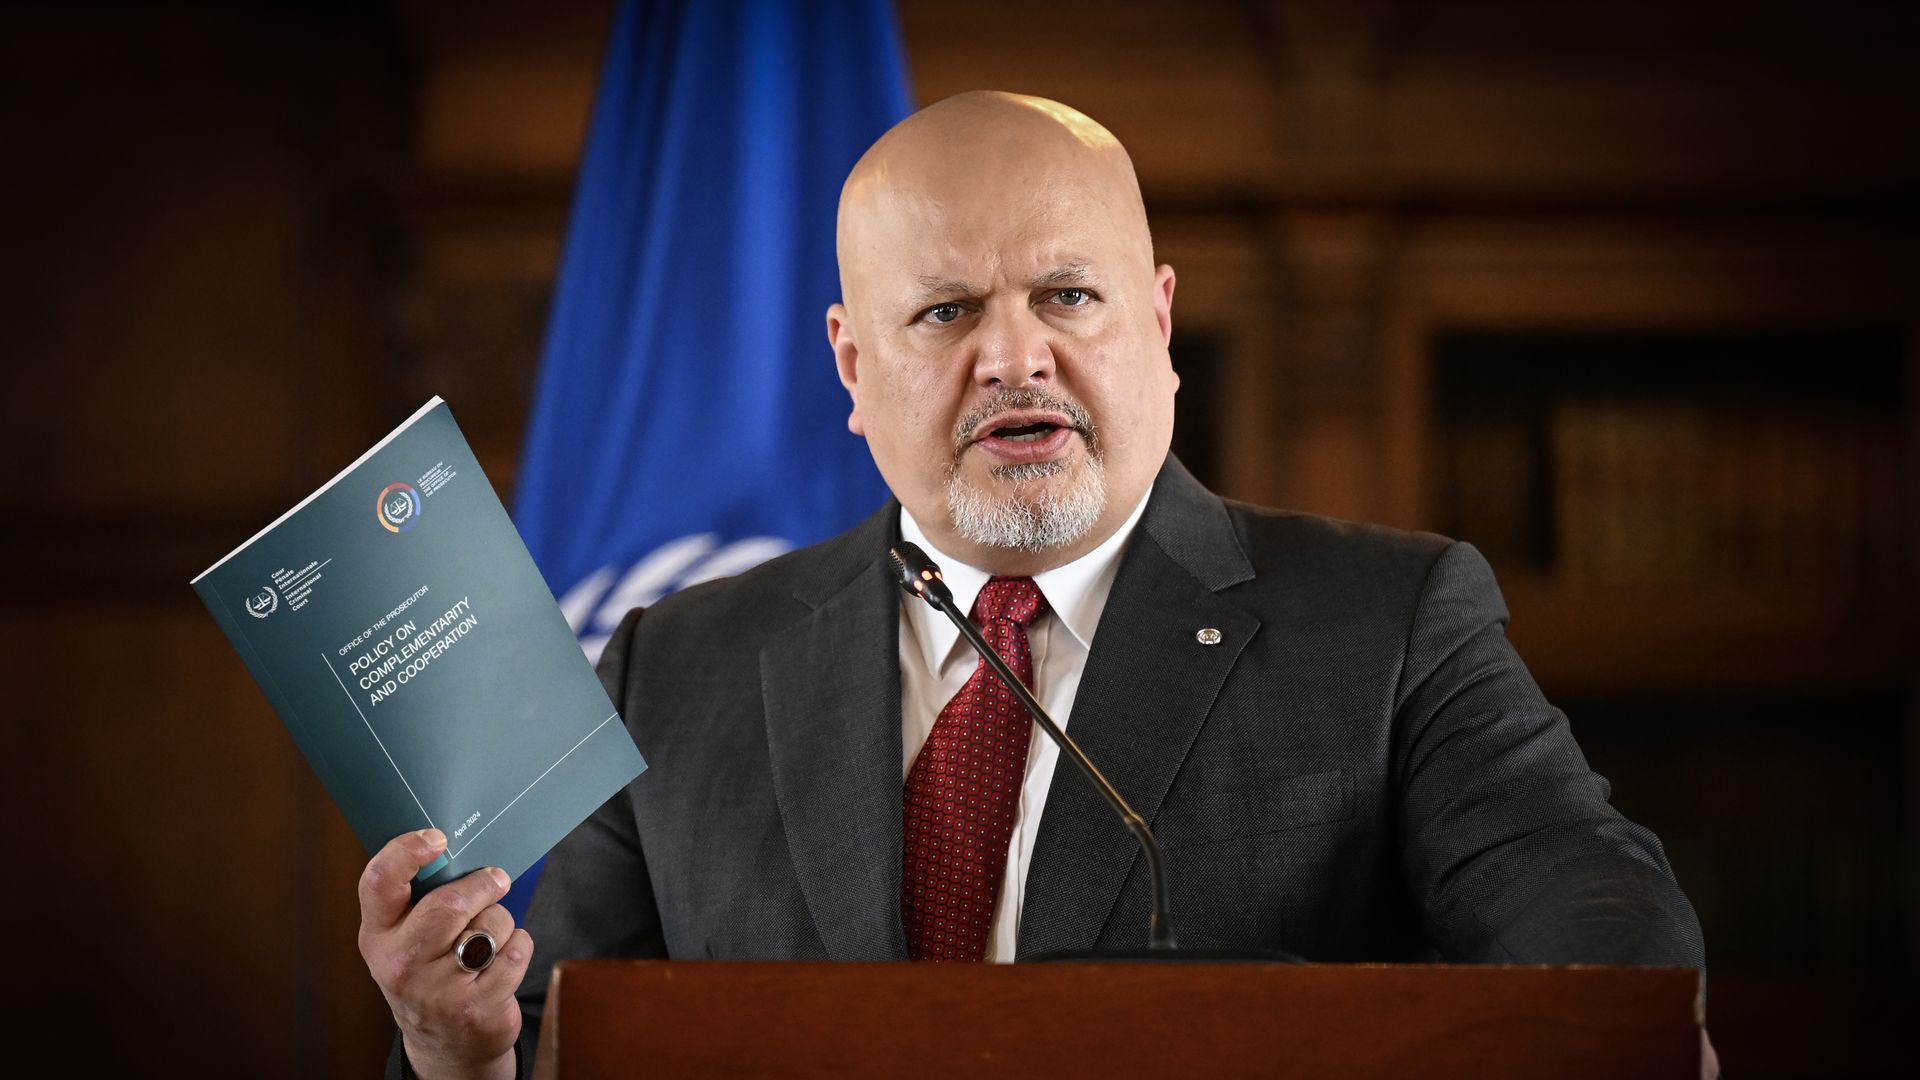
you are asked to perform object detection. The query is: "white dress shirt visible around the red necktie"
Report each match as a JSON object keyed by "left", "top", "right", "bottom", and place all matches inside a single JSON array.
[{"left": 900, "top": 492, "right": 1150, "bottom": 963}]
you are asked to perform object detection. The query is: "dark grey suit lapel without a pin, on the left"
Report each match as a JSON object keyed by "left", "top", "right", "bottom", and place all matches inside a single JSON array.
[{"left": 760, "top": 503, "right": 906, "bottom": 961}]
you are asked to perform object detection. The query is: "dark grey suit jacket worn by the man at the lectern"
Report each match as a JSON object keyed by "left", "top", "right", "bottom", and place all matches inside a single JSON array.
[{"left": 397, "top": 457, "right": 1703, "bottom": 1063}]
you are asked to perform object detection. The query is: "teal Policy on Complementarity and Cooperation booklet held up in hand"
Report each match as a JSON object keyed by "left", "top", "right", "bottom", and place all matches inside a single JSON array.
[{"left": 194, "top": 398, "right": 647, "bottom": 892}]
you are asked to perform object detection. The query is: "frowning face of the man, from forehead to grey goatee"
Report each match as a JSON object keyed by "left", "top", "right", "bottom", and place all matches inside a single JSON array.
[{"left": 828, "top": 163, "right": 1179, "bottom": 573}]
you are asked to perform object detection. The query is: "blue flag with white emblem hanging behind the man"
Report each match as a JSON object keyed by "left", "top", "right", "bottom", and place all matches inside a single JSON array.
[{"left": 507, "top": 0, "right": 910, "bottom": 919}]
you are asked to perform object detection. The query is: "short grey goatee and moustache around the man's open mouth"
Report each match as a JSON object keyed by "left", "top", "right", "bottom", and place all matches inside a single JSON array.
[{"left": 947, "top": 388, "right": 1106, "bottom": 552}]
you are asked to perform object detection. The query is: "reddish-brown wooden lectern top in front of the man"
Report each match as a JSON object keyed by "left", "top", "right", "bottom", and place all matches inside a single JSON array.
[{"left": 534, "top": 961, "right": 1703, "bottom": 1080}]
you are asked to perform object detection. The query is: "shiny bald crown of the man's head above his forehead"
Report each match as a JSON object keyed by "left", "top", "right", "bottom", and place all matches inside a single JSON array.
[{"left": 835, "top": 90, "right": 1154, "bottom": 302}]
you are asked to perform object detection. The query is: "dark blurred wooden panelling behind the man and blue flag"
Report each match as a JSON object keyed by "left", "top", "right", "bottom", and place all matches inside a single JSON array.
[{"left": 0, "top": 0, "right": 1920, "bottom": 1076}]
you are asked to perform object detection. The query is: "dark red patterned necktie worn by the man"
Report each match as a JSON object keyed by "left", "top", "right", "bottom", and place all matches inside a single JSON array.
[{"left": 900, "top": 578, "right": 1046, "bottom": 963}]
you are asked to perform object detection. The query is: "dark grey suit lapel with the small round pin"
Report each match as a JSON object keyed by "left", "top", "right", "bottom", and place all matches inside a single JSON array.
[{"left": 1020, "top": 457, "right": 1260, "bottom": 957}]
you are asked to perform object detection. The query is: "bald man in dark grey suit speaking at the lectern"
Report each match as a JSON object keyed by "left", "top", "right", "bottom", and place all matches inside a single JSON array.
[{"left": 361, "top": 94, "right": 1701, "bottom": 1076}]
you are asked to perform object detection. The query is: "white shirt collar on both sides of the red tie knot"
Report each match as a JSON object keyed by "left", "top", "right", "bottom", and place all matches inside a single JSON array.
[{"left": 900, "top": 488, "right": 1152, "bottom": 675}]
